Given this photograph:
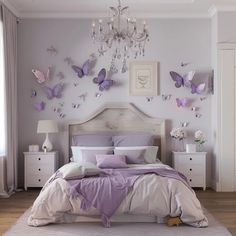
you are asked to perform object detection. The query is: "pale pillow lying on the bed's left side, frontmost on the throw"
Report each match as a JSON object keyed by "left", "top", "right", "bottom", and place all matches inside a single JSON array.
[{"left": 59, "top": 162, "right": 101, "bottom": 179}]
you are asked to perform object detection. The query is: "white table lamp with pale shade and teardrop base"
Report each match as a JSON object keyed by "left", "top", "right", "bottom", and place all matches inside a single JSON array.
[{"left": 37, "top": 120, "right": 58, "bottom": 152}]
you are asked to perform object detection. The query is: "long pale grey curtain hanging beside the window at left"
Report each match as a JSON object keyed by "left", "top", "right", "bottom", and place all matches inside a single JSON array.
[{"left": 1, "top": 5, "right": 18, "bottom": 195}]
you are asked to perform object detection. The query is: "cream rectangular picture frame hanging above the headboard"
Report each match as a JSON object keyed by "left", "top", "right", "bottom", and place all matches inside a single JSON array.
[{"left": 129, "top": 61, "right": 159, "bottom": 96}]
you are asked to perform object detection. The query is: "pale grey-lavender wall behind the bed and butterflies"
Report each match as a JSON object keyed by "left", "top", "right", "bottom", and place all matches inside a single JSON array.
[{"left": 18, "top": 19, "right": 212, "bottom": 186}]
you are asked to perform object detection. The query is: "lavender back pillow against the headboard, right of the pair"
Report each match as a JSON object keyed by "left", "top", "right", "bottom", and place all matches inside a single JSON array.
[{"left": 112, "top": 134, "right": 154, "bottom": 147}]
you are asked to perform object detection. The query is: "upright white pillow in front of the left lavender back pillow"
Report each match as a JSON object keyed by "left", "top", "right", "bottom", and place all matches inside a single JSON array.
[{"left": 71, "top": 146, "right": 114, "bottom": 164}]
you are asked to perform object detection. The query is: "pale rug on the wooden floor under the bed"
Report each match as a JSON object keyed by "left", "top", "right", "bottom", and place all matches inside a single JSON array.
[{"left": 3, "top": 210, "right": 231, "bottom": 236}]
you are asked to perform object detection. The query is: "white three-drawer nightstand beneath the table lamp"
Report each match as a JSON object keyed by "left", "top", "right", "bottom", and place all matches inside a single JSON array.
[{"left": 24, "top": 151, "right": 58, "bottom": 190}]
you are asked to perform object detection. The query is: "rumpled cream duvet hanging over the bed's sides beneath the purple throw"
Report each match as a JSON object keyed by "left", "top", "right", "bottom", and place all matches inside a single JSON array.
[{"left": 28, "top": 164, "right": 208, "bottom": 227}]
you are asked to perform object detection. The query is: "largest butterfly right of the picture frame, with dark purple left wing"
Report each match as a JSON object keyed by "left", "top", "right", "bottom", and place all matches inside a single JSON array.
[{"left": 170, "top": 71, "right": 195, "bottom": 88}]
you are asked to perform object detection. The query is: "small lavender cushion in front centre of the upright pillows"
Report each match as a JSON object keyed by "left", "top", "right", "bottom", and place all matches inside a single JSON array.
[{"left": 96, "top": 155, "right": 128, "bottom": 169}]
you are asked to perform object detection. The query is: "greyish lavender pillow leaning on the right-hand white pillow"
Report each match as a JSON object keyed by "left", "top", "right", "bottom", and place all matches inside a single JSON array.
[{"left": 114, "top": 149, "right": 146, "bottom": 164}]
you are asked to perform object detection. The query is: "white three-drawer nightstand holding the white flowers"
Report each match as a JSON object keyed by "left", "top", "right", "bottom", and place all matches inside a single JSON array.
[{"left": 172, "top": 152, "right": 207, "bottom": 190}]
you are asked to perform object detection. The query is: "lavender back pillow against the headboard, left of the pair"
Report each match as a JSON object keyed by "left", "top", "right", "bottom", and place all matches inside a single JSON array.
[{"left": 72, "top": 134, "right": 113, "bottom": 147}]
